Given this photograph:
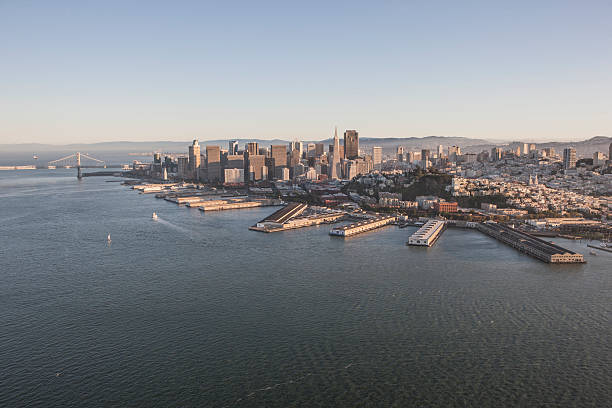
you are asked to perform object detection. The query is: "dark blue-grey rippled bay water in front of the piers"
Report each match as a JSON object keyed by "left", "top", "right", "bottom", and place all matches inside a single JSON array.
[{"left": 0, "top": 170, "right": 612, "bottom": 407}]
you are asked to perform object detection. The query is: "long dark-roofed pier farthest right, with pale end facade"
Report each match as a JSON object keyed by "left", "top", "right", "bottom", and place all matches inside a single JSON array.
[{"left": 476, "top": 222, "right": 585, "bottom": 263}]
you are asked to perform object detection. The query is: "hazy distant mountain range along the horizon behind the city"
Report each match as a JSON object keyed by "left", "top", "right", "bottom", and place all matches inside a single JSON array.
[{"left": 0, "top": 136, "right": 612, "bottom": 165}]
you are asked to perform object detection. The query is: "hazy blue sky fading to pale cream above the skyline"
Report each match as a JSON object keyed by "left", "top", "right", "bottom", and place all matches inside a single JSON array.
[{"left": 0, "top": 0, "right": 612, "bottom": 143}]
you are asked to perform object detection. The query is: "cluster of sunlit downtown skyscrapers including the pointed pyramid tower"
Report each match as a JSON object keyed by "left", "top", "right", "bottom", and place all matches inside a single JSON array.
[{"left": 152, "top": 130, "right": 382, "bottom": 185}]
